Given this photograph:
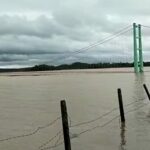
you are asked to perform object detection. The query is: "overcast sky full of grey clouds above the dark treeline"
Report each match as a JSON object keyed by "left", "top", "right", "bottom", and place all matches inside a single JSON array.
[{"left": 0, "top": 0, "right": 150, "bottom": 67}]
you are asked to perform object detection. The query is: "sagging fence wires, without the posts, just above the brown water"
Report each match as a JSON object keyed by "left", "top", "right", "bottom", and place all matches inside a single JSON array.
[{"left": 0, "top": 85, "right": 147, "bottom": 150}]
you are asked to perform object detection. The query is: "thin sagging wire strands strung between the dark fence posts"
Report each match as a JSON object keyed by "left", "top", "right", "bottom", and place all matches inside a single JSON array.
[{"left": 0, "top": 93, "right": 147, "bottom": 150}]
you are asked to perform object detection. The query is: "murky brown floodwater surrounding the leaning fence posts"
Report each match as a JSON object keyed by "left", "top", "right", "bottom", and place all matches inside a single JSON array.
[{"left": 0, "top": 69, "right": 150, "bottom": 150}]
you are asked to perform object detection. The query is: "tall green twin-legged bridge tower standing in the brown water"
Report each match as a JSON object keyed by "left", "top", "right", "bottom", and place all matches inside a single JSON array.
[{"left": 133, "top": 23, "right": 143, "bottom": 73}]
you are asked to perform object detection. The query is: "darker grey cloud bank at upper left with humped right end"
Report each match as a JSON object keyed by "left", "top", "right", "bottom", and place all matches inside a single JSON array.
[{"left": 0, "top": 15, "right": 61, "bottom": 38}]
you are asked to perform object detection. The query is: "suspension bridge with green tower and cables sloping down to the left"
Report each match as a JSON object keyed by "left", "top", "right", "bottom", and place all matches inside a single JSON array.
[{"left": 50, "top": 23, "right": 150, "bottom": 73}]
